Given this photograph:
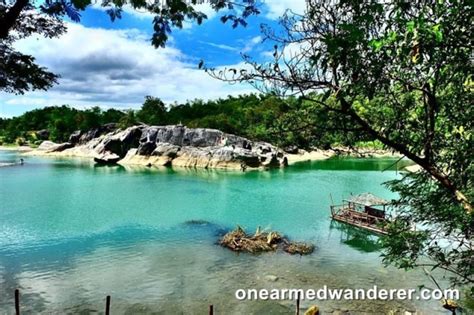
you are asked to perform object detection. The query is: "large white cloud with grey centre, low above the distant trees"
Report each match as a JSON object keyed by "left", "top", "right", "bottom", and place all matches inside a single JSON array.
[{"left": 0, "top": 24, "right": 254, "bottom": 112}]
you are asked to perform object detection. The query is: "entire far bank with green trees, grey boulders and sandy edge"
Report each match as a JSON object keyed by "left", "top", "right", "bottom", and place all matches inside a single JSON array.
[{"left": 0, "top": 94, "right": 408, "bottom": 170}]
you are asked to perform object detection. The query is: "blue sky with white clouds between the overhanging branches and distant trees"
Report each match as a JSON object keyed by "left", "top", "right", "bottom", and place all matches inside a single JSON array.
[{"left": 0, "top": 0, "right": 305, "bottom": 117}]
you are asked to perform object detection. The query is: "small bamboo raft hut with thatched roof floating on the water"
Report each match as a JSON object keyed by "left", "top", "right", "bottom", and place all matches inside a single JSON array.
[{"left": 331, "top": 193, "right": 389, "bottom": 234}]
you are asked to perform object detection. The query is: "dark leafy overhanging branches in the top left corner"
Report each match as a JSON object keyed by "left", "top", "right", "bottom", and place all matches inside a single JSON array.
[{"left": 0, "top": 0, "right": 259, "bottom": 94}]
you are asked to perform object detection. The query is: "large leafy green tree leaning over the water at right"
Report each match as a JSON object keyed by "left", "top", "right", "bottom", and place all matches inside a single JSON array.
[{"left": 206, "top": 0, "right": 474, "bottom": 292}]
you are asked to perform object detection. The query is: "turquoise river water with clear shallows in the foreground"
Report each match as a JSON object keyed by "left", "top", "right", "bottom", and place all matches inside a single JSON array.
[{"left": 0, "top": 151, "right": 452, "bottom": 314}]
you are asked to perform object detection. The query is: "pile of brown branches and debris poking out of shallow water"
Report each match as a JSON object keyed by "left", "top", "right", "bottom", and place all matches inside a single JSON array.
[{"left": 219, "top": 226, "right": 314, "bottom": 255}]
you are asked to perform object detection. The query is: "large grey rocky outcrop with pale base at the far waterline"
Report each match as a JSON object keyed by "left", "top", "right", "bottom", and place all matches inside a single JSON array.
[{"left": 35, "top": 125, "right": 287, "bottom": 170}]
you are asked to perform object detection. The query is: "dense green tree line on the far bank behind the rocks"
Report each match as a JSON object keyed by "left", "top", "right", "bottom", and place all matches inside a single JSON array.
[{"left": 0, "top": 94, "right": 371, "bottom": 148}]
